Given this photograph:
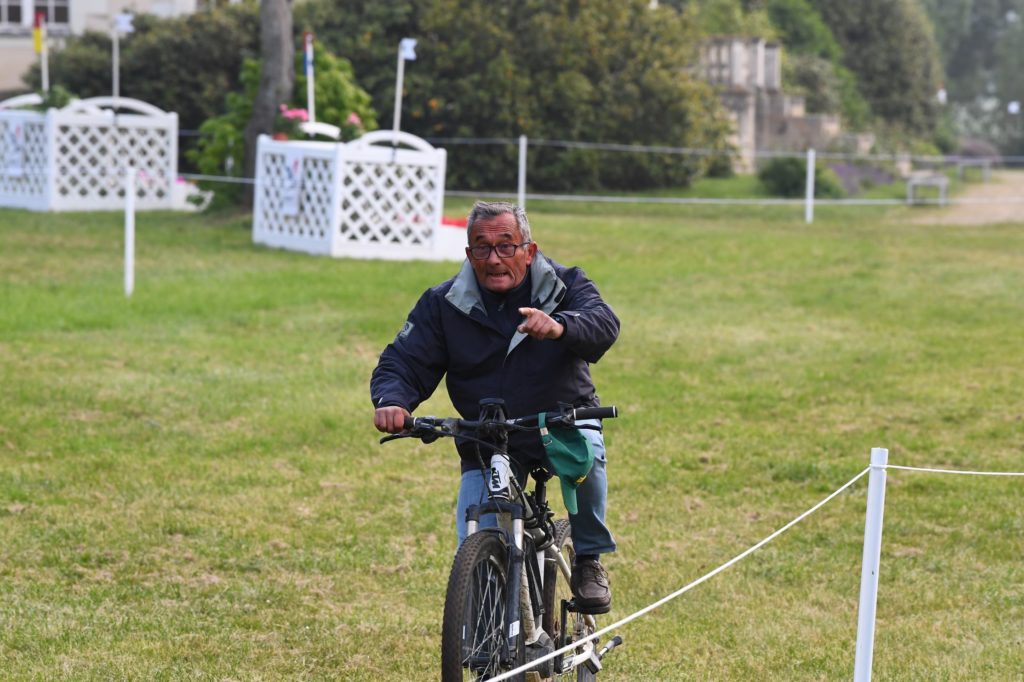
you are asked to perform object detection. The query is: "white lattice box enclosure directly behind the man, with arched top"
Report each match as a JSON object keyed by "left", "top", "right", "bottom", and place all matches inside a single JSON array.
[{"left": 253, "top": 131, "right": 450, "bottom": 260}]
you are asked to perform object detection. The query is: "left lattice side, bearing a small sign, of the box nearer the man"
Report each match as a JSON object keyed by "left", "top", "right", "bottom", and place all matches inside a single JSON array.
[{"left": 253, "top": 137, "right": 338, "bottom": 254}]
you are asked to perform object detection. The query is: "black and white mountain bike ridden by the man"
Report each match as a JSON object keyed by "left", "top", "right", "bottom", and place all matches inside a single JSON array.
[{"left": 381, "top": 399, "right": 623, "bottom": 682}]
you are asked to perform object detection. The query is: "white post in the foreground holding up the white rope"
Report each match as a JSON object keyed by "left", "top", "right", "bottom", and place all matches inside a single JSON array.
[{"left": 853, "top": 447, "right": 889, "bottom": 682}]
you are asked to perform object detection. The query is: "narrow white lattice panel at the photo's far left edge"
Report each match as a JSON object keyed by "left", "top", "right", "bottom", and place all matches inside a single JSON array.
[{"left": 0, "top": 112, "right": 48, "bottom": 210}]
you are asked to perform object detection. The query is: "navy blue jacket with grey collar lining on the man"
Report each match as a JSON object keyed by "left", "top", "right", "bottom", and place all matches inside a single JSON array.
[{"left": 370, "top": 252, "right": 618, "bottom": 470}]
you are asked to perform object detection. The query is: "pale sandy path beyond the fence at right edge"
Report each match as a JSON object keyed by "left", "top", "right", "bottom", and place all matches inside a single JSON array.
[{"left": 911, "top": 170, "right": 1024, "bottom": 225}]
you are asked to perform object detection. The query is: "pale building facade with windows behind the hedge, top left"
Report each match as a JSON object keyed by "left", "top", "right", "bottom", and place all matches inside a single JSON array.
[{"left": 0, "top": 0, "right": 197, "bottom": 92}]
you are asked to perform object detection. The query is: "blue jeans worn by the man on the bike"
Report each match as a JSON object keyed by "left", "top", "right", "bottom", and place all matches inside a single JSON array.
[{"left": 455, "top": 420, "right": 615, "bottom": 554}]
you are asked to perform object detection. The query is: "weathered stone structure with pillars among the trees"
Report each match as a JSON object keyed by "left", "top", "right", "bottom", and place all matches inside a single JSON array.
[{"left": 700, "top": 37, "right": 842, "bottom": 172}]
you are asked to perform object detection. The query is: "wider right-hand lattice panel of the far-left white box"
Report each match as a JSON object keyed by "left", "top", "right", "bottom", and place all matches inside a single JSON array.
[{"left": 50, "top": 113, "right": 177, "bottom": 210}]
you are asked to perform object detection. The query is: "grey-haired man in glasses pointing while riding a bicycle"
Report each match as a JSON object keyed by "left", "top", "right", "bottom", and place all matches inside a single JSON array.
[{"left": 370, "top": 202, "right": 620, "bottom": 613}]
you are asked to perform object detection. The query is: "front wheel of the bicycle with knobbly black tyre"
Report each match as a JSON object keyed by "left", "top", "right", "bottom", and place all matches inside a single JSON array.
[{"left": 441, "top": 531, "right": 524, "bottom": 682}]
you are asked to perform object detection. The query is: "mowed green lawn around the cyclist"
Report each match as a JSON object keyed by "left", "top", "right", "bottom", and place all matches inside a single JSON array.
[{"left": 0, "top": 202, "right": 1024, "bottom": 682}]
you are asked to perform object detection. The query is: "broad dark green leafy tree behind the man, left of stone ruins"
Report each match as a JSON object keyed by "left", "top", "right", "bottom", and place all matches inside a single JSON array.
[{"left": 297, "top": 0, "right": 728, "bottom": 188}]
